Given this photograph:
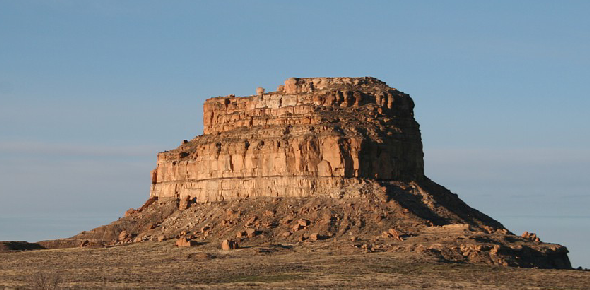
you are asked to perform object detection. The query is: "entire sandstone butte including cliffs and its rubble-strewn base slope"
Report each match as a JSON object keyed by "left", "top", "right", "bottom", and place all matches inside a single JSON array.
[{"left": 39, "top": 77, "right": 571, "bottom": 268}]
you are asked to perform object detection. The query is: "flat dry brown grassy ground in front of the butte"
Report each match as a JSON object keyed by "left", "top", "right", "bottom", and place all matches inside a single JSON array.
[{"left": 0, "top": 240, "right": 590, "bottom": 290}]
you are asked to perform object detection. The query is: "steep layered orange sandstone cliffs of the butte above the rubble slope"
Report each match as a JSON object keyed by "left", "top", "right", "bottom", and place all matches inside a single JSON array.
[{"left": 151, "top": 77, "right": 424, "bottom": 202}]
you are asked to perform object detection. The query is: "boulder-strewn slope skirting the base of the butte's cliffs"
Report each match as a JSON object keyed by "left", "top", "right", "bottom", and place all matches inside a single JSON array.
[{"left": 40, "top": 180, "right": 571, "bottom": 269}]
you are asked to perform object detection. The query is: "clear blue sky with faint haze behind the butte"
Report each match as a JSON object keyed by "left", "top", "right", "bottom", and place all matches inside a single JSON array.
[{"left": 0, "top": 0, "right": 590, "bottom": 267}]
